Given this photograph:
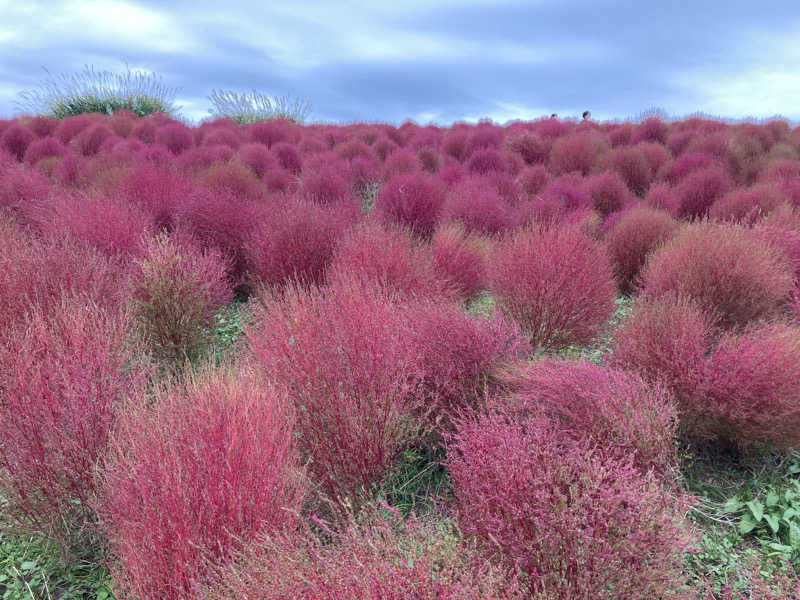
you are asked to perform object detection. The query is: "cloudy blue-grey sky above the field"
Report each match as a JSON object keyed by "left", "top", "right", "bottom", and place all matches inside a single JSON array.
[{"left": 0, "top": 0, "right": 800, "bottom": 125}]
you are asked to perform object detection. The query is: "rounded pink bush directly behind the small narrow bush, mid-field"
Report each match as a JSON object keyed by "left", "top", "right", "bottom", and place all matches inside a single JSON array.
[{"left": 441, "top": 177, "right": 517, "bottom": 234}]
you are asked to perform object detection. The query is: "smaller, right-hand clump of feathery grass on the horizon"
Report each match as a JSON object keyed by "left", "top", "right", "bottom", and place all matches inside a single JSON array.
[{"left": 208, "top": 90, "right": 311, "bottom": 125}]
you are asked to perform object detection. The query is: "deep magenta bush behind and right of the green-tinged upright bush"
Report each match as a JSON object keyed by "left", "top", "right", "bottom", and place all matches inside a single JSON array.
[{"left": 244, "top": 199, "right": 357, "bottom": 287}]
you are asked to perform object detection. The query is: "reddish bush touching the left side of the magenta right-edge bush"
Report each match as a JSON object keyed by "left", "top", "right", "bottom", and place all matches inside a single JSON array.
[{"left": 609, "top": 294, "right": 714, "bottom": 408}]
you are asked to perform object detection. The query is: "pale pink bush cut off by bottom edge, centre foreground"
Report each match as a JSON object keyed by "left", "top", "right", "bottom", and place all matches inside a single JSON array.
[{"left": 200, "top": 506, "right": 524, "bottom": 600}]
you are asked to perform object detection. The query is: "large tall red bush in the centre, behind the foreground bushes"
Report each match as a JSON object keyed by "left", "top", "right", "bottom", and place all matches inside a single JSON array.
[{"left": 245, "top": 278, "right": 424, "bottom": 498}]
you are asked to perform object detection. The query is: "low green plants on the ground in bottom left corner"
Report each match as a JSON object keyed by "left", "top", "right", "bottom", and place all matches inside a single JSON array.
[{"left": 0, "top": 533, "right": 114, "bottom": 600}]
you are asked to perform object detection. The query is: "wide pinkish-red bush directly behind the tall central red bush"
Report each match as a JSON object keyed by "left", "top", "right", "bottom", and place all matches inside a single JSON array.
[{"left": 329, "top": 223, "right": 453, "bottom": 298}]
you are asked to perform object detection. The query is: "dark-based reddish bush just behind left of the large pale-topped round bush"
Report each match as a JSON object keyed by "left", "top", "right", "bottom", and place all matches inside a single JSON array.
[{"left": 605, "top": 206, "right": 678, "bottom": 294}]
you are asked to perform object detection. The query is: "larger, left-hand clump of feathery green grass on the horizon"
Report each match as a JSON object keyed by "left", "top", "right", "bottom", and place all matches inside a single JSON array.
[{"left": 16, "top": 65, "right": 177, "bottom": 119}]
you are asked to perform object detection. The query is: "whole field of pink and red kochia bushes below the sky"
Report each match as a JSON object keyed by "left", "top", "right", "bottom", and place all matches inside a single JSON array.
[{"left": 0, "top": 110, "right": 800, "bottom": 600}]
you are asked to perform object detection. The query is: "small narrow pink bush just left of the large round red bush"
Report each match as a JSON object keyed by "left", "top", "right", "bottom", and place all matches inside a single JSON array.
[{"left": 431, "top": 223, "right": 489, "bottom": 300}]
